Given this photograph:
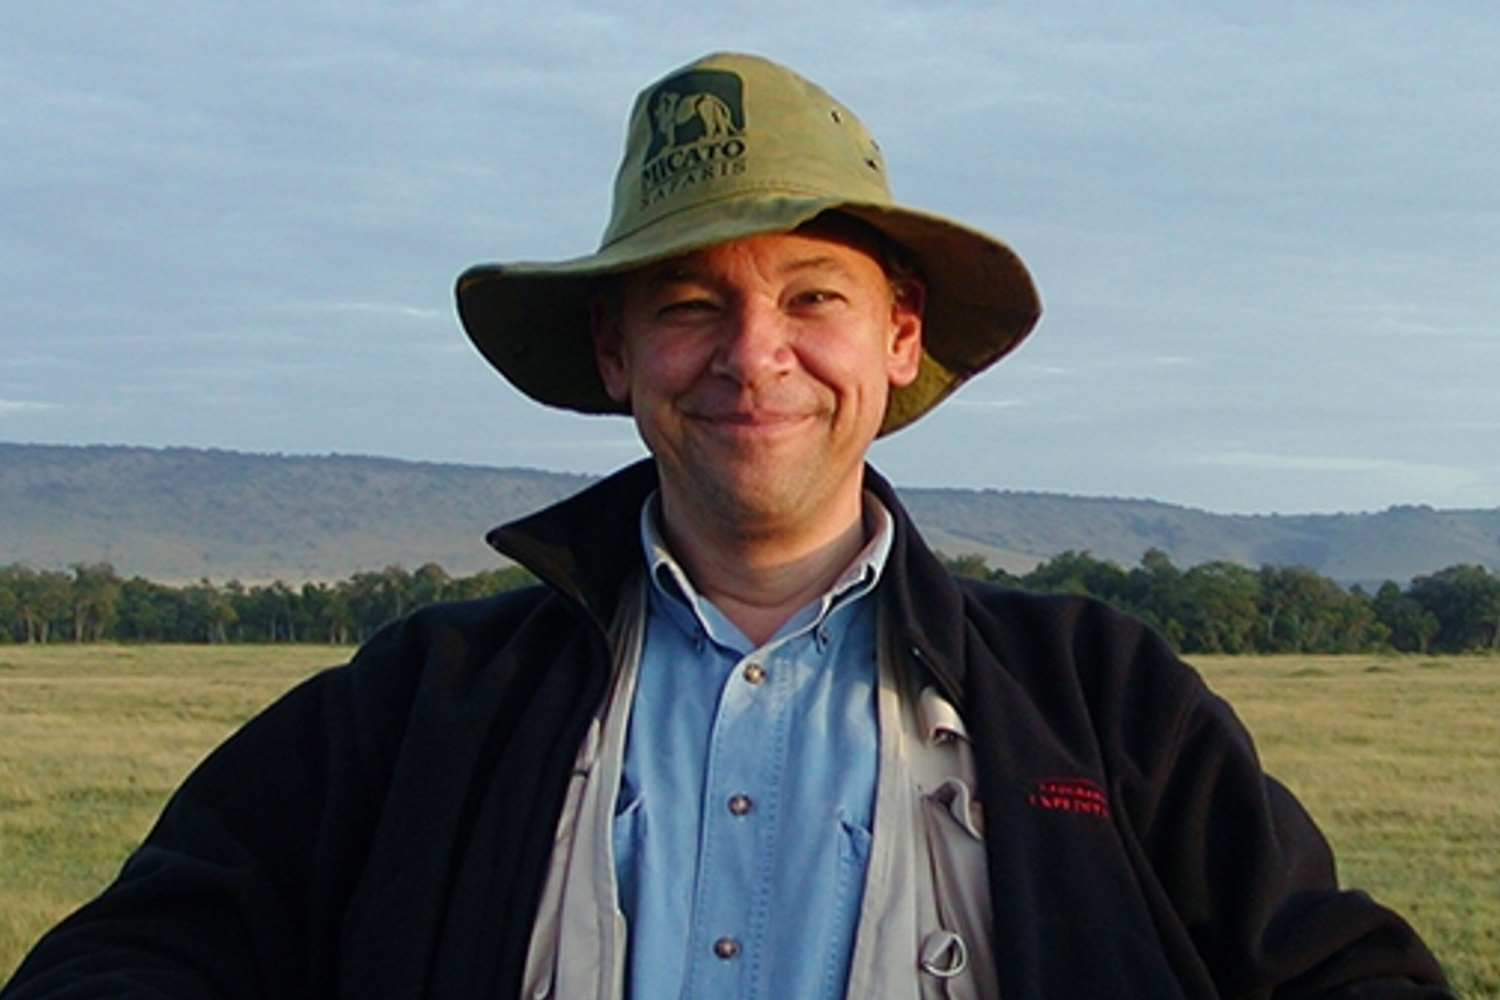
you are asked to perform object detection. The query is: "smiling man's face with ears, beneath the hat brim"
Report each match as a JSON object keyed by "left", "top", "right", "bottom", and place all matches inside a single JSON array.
[{"left": 596, "top": 225, "right": 921, "bottom": 531}]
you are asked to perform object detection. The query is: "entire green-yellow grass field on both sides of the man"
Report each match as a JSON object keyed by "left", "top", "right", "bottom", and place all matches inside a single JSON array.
[{"left": 0, "top": 645, "right": 1500, "bottom": 1000}]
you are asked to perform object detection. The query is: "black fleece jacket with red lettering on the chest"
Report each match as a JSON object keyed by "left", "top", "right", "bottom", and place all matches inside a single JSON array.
[{"left": 3, "top": 463, "right": 1451, "bottom": 1000}]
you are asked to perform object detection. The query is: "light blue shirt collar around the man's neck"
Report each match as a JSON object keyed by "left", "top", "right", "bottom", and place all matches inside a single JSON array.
[{"left": 641, "top": 490, "right": 896, "bottom": 652}]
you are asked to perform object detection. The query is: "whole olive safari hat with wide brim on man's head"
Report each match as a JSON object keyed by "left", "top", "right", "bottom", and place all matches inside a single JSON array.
[{"left": 458, "top": 54, "right": 1041, "bottom": 433}]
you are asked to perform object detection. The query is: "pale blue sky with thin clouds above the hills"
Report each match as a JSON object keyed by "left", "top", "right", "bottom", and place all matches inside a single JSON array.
[{"left": 0, "top": 0, "right": 1500, "bottom": 514}]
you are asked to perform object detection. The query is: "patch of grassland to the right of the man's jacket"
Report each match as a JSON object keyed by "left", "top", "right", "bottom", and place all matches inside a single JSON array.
[{"left": 1191, "top": 655, "right": 1500, "bottom": 1000}]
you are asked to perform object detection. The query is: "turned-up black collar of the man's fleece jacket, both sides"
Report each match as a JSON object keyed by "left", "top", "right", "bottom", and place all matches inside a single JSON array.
[{"left": 486, "top": 459, "right": 965, "bottom": 700}]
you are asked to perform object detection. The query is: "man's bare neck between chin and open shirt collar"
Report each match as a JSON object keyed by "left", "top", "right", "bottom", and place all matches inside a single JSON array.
[{"left": 662, "top": 490, "right": 866, "bottom": 646}]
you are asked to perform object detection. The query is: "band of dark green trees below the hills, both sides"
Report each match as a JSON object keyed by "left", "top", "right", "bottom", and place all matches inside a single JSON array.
[{"left": 0, "top": 549, "right": 1500, "bottom": 654}]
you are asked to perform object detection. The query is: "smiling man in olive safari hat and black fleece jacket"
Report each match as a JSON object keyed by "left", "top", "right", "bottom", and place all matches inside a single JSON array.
[{"left": 8, "top": 55, "right": 1448, "bottom": 999}]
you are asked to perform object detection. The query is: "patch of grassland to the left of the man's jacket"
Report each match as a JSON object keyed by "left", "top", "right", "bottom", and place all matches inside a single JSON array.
[{"left": 0, "top": 643, "right": 351, "bottom": 982}]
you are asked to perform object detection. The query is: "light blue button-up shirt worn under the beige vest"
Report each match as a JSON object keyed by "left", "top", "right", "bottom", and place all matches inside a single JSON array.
[{"left": 612, "top": 498, "right": 893, "bottom": 1000}]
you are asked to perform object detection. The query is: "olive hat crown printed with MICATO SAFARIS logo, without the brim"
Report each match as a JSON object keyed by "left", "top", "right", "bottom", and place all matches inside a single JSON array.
[{"left": 602, "top": 52, "right": 891, "bottom": 249}]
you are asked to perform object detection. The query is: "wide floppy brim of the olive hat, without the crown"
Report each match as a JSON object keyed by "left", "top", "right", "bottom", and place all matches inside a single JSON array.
[{"left": 456, "top": 195, "right": 1041, "bottom": 435}]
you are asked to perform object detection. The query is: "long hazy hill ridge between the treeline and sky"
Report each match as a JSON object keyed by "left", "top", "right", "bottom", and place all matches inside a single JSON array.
[{"left": 0, "top": 442, "right": 1500, "bottom": 583}]
